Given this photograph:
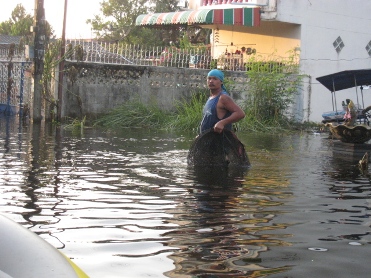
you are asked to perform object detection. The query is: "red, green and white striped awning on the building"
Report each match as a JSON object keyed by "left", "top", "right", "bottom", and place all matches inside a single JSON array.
[{"left": 135, "top": 7, "right": 260, "bottom": 27}]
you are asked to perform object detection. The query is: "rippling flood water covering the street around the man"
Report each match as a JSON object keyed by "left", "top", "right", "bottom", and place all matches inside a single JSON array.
[{"left": 0, "top": 116, "right": 371, "bottom": 278}]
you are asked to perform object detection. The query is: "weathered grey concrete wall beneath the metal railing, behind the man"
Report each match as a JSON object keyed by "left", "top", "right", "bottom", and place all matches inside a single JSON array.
[{"left": 62, "top": 62, "right": 248, "bottom": 118}]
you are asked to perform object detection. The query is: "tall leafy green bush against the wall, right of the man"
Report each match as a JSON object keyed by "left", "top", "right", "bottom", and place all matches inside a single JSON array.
[{"left": 243, "top": 51, "right": 303, "bottom": 131}]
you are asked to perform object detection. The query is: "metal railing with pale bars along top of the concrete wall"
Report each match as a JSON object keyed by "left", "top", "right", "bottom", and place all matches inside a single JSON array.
[{"left": 0, "top": 39, "right": 296, "bottom": 72}]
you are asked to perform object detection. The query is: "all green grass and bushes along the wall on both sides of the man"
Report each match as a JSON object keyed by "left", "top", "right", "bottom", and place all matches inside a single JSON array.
[{"left": 95, "top": 52, "right": 310, "bottom": 133}]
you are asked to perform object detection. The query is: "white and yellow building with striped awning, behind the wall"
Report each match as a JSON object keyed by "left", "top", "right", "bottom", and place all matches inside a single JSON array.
[{"left": 136, "top": 0, "right": 371, "bottom": 122}]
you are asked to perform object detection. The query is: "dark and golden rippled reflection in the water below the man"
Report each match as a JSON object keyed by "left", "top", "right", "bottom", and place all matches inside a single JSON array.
[{"left": 165, "top": 167, "right": 286, "bottom": 277}]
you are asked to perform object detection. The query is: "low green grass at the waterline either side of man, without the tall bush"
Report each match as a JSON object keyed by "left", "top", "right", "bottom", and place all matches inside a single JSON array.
[{"left": 91, "top": 91, "right": 320, "bottom": 133}]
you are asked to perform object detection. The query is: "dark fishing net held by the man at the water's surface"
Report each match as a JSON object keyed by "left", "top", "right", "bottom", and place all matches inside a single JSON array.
[{"left": 187, "top": 129, "right": 250, "bottom": 167}]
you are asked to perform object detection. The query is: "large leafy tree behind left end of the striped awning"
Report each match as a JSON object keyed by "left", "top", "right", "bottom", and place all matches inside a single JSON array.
[{"left": 87, "top": 0, "right": 178, "bottom": 44}]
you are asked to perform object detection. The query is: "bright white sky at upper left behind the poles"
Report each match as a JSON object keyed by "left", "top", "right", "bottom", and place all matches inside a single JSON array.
[{"left": 0, "top": 0, "right": 102, "bottom": 39}]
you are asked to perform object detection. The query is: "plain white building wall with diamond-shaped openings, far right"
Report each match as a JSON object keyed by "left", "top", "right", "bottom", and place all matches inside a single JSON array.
[{"left": 277, "top": 0, "right": 371, "bottom": 122}]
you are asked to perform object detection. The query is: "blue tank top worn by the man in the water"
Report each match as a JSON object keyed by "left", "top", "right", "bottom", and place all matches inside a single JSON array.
[{"left": 200, "top": 91, "right": 232, "bottom": 133}]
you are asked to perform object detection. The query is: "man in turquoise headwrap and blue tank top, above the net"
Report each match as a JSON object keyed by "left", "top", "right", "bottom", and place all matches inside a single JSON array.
[{"left": 200, "top": 69, "right": 245, "bottom": 133}]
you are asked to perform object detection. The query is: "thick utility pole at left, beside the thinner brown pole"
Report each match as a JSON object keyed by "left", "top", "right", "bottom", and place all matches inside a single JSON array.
[{"left": 33, "top": 0, "right": 46, "bottom": 123}]
